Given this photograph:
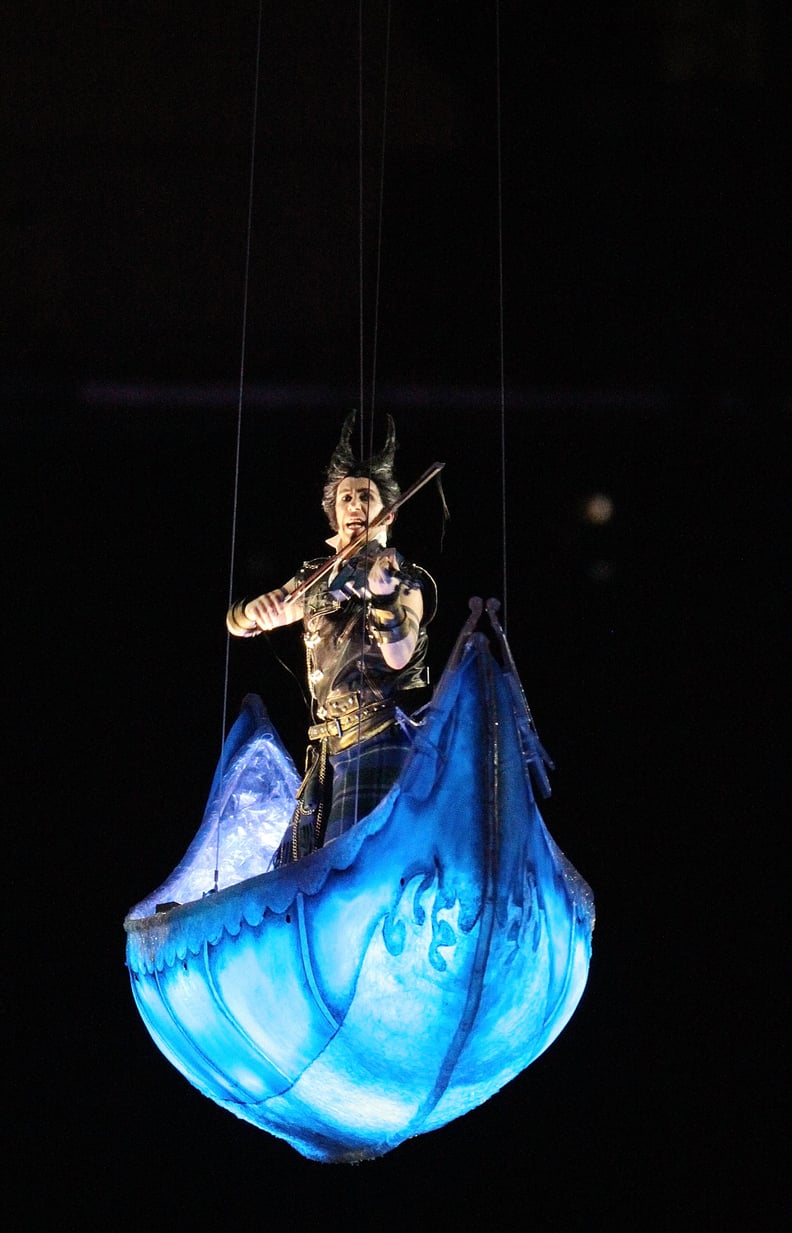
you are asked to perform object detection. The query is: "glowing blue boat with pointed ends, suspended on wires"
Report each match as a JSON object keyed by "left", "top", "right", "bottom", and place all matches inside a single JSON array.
[{"left": 125, "top": 600, "right": 593, "bottom": 1161}]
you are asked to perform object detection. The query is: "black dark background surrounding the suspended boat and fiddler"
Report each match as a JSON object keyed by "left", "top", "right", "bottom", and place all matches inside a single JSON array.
[{"left": 0, "top": 0, "right": 790, "bottom": 1231}]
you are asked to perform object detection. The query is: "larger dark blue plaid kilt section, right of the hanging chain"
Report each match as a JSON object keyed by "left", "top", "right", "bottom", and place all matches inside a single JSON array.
[{"left": 324, "top": 724, "right": 412, "bottom": 843}]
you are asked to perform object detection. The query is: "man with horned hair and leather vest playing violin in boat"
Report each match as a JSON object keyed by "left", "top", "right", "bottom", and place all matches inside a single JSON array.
[{"left": 226, "top": 412, "right": 437, "bottom": 866}]
